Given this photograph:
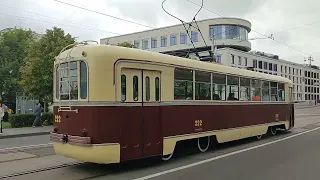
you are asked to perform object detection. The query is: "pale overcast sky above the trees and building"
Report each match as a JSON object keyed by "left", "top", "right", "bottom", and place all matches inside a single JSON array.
[{"left": 0, "top": 0, "right": 320, "bottom": 65}]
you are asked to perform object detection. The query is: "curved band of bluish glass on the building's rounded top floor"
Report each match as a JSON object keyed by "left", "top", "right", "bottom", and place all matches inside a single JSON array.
[{"left": 209, "top": 25, "right": 248, "bottom": 40}]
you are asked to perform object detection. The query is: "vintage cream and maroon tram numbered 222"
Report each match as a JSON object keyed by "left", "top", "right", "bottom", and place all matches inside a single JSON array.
[{"left": 50, "top": 41, "right": 294, "bottom": 164}]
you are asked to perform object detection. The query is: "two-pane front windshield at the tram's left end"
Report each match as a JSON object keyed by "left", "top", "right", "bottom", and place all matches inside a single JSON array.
[{"left": 59, "top": 61, "right": 78, "bottom": 100}]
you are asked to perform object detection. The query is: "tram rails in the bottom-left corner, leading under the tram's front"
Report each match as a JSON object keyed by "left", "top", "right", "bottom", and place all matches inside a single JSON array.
[{"left": 0, "top": 162, "right": 87, "bottom": 179}]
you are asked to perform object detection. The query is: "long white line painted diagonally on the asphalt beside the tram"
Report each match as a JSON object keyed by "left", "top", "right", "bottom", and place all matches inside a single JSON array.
[{"left": 134, "top": 127, "right": 320, "bottom": 180}]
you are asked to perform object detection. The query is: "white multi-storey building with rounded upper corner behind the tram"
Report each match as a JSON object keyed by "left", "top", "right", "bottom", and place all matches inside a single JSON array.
[{"left": 100, "top": 18, "right": 320, "bottom": 101}]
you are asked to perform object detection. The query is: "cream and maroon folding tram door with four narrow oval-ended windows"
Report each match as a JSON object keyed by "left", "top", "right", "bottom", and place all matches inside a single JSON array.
[{"left": 117, "top": 69, "right": 162, "bottom": 160}]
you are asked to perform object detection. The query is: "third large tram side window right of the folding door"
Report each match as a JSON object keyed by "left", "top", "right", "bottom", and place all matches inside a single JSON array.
[{"left": 212, "top": 73, "right": 226, "bottom": 101}]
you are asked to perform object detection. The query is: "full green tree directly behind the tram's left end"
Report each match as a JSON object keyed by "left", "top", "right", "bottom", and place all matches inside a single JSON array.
[{"left": 20, "top": 27, "right": 75, "bottom": 108}]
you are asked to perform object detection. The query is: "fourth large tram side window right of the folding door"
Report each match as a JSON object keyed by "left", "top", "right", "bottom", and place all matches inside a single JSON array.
[{"left": 227, "top": 76, "right": 239, "bottom": 101}]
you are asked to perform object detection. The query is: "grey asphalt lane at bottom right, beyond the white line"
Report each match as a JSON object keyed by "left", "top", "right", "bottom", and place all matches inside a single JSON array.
[{"left": 134, "top": 127, "right": 320, "bottom": 180}]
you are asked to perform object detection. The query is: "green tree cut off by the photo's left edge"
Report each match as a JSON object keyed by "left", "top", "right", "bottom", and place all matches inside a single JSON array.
[{"left": 0, "top": 28, "right": 34, "bottom": 109}]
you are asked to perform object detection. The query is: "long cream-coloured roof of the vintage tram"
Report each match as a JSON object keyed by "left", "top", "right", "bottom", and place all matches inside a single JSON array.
[{"left": 60, "top": 45, "right": 292, "bottom": 84}]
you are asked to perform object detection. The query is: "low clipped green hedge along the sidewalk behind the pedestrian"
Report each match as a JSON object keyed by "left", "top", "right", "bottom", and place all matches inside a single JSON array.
[{"left": 9, "top": 113, "right": 54, "bottom": 128}]
